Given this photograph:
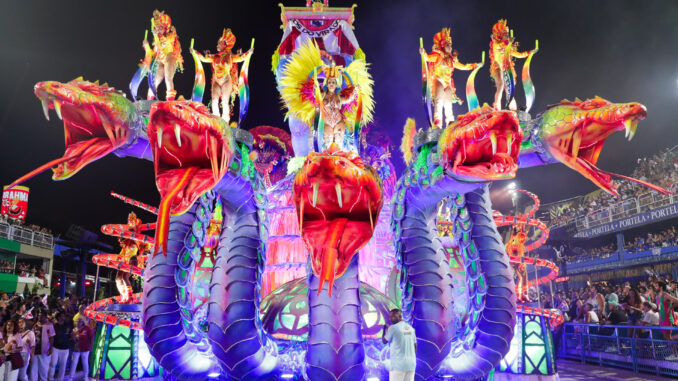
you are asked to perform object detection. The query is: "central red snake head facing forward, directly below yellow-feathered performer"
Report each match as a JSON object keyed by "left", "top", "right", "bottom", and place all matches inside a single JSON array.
[{"left": 294, "top": 145, "right": 383, "bottom": 295}]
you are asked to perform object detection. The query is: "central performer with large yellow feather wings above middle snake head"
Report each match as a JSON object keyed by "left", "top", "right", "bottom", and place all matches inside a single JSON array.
[{"left": 280, "top": 41, "right": 374, "bottom": 151}]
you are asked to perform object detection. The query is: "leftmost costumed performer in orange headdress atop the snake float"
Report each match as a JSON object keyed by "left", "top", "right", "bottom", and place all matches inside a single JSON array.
[{"left": 143, "top": 9, "right": 184, "bottom": 101}]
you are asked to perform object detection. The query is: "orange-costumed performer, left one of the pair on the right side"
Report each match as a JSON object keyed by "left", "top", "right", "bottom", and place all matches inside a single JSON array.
[{"left": 419, "top": 28, "right": 480, "bottom": 128}]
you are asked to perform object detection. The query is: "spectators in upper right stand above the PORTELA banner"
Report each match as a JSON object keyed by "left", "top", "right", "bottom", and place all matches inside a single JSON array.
[{"left": 549, "top": 149, "right": 678, "bottom": 226}]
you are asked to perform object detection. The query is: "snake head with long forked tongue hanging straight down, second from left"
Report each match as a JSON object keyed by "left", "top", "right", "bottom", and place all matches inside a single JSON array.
[{"left": 148, "top": 100, "right": 235, "bottom": 254}]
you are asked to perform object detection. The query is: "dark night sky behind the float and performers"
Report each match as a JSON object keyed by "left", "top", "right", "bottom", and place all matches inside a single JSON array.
[{"left": 0, "top": 0, "right": 678, "bottom": 238}]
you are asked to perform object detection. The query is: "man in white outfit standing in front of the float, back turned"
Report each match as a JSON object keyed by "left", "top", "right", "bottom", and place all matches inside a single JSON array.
[{"left": 381, "top": 308, "right": 417, "bottom": 381}]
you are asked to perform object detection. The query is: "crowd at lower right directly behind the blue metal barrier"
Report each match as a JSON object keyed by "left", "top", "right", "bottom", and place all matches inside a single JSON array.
[{"left": 556, "top": 275, "right": 678, "bottom": 360}]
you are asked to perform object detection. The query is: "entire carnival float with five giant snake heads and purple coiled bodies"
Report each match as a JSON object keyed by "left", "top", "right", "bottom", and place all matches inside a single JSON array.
[{"left": 6, "top": 1, "right": 666, "bottom": 380}]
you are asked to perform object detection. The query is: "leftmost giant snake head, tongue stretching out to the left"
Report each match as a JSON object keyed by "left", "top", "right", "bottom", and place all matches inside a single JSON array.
[{"left": 12, "top": 77, "right": 140, "bottom": 189}]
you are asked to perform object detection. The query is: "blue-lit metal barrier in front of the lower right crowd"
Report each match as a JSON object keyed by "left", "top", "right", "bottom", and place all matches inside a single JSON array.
[{"left": 559, "top": 323, "right": 678, "bottom": 377}]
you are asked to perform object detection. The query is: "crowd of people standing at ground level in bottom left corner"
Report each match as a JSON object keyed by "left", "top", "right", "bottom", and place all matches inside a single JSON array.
[{"left": 0, "top": 292, "right": 94, "bottom": 381}]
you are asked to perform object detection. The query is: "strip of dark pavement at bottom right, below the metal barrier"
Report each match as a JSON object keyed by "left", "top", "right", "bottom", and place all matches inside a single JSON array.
[{"left": 558, "top": 360, "right": 672, "bottom": 381}]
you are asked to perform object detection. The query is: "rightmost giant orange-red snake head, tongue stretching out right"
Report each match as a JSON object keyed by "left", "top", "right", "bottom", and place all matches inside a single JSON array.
[{"left": 535, "top": 97, "right": 668, "bottom": 196}]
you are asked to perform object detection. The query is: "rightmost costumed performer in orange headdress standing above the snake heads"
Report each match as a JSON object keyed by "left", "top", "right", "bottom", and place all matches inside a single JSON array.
[{"left": 490, "top": 20, "right": 531, "bottom": 110}]
